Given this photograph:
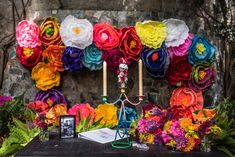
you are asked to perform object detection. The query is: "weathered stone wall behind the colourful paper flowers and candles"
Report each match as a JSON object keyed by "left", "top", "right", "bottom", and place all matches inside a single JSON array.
[{"left": 0, "top": 0, "right": 223, "bottom": 107}]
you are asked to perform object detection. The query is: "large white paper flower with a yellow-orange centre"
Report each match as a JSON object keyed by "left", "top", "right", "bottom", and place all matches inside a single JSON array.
[{"left": 60, "top": 15, "right": 93, "bottom": 49}]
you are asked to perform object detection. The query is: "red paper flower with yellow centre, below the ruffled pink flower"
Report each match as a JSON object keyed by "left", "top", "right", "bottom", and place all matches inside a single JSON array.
[{"left": 16, "top": 45, "right": 42, "bottom": 69}]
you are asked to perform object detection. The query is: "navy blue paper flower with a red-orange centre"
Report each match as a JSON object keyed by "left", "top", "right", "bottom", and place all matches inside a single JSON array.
[{"left": 141, "top": 46, "right": 169, "bottom": 77}]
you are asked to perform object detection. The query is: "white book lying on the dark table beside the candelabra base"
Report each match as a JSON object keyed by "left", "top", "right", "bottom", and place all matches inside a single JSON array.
[{"left": 78, "top": 128, "right": 126, "bottom": 144}]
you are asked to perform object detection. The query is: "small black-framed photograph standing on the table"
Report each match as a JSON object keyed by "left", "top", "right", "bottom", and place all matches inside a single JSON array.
[{"left": 60, "top": 115, "right": 76, "bottom": 139}]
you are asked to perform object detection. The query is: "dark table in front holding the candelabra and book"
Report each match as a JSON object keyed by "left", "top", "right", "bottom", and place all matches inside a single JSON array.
[{"left": 15, "top": 135, "right": 226, "bottom": 157}]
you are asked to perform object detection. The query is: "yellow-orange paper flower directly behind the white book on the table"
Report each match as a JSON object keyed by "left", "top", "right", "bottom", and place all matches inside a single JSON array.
[{"left": 95, "top": 104, "right": 118, "bottom": 128}]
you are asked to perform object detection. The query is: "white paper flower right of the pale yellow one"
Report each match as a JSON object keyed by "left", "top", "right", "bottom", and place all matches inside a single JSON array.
[{"left": 163, "top": 18, "right": 189, "bottom": 47}]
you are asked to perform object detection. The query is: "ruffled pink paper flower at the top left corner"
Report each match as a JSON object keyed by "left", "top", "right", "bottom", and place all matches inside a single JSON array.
[{"left": 16, "top": 20, "right": 41, "bottom": 48}]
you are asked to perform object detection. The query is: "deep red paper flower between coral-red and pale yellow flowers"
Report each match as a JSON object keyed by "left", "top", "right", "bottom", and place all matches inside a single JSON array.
[{"left": 119, "top": 27, "right": 142, "bottom": 61}]
